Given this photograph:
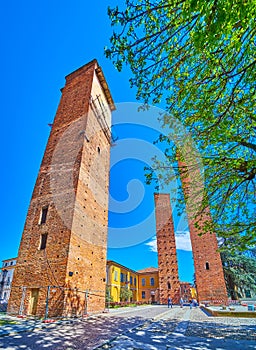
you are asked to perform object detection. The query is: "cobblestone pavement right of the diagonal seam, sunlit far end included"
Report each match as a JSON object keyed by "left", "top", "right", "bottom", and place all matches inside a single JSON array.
[{"left": 98, "top": 307, "right": 256, "bottom": 350}]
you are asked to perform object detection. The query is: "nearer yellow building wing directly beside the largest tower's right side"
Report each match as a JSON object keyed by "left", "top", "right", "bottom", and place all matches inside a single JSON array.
[{"left": 107, "top": 260, "right": 138, "bottom": 302}]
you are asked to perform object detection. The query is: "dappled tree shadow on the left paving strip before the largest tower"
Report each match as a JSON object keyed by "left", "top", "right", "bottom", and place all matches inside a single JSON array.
[{"left": 0, "top": 317, "right": 145, "bottom": 350}]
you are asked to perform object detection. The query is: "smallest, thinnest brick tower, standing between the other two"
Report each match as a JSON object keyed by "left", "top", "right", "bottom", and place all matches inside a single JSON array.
[{"left": 154, "top": 193, "right": 180, "bottom": 304}]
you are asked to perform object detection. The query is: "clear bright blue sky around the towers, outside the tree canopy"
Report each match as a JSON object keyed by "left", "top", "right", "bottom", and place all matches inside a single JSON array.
[{"left": 0, "top": 0, "right": 193, "bottom": 281}]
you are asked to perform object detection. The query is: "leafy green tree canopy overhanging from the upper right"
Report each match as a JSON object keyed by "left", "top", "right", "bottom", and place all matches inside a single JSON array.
[{"left": 105, "top": 0, "right": 256, "bottom": 250}]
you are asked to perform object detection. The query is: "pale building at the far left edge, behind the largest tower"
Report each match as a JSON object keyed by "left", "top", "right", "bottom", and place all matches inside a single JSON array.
[{"left": 0, "top": 258, "right": 17, "bottom": 302}]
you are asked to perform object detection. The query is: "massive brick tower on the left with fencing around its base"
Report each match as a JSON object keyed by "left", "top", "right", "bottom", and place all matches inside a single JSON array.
[{"left": 8, "top": 60, "right": 115, "bottom": 317}]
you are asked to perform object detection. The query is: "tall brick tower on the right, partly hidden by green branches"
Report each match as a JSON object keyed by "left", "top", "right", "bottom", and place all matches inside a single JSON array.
[{"left": 179, "top": 157, "right": 228, "bottom": 304}]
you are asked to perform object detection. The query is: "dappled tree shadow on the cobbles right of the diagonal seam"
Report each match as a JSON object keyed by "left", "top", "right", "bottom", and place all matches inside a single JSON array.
[{"left": 96, "top": 319, "right": 256, "bottom": 350}]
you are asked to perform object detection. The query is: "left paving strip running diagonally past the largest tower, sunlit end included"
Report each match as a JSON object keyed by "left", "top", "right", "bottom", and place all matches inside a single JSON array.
[{"left": 0, "top": 306, "right": 167, "bottom": 350}]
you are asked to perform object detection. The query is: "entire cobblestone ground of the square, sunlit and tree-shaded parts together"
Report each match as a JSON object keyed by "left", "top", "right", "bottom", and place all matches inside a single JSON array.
[{"left": 0, "top": 306, "right": 256, "bottom": 350}]
